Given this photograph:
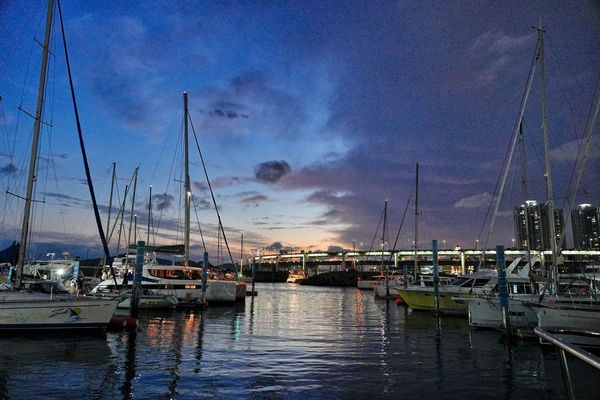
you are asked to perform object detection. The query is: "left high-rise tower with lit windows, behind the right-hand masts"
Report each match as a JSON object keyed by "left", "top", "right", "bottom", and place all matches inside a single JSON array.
[{"left": 514, "top": 200, "right": 566, "bottom": 250}]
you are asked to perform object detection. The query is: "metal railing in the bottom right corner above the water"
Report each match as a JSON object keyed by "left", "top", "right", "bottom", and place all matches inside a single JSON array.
[{"left": 533, "top": 328, "right": 600, "bottom": 400}]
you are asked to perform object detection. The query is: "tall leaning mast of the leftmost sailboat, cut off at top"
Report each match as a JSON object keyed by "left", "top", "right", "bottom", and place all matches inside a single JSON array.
[{"left": 15, "top": 0, "right": 54, "bottom": 287}]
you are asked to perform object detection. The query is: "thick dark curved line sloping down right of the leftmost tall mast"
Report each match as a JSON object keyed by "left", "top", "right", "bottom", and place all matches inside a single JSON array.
[{"left": 56, "top": 0, "right": 116, "bottom": 268}]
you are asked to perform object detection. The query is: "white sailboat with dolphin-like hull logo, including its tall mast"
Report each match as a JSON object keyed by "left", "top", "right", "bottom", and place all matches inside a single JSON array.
[{"left": 0, "top": 0, "right": 118, "bottom": 331}]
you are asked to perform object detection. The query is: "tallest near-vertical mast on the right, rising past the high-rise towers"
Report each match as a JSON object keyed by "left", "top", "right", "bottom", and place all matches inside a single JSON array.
[{"left": 538, "top": 25, "right": 558, "bottom": 286}]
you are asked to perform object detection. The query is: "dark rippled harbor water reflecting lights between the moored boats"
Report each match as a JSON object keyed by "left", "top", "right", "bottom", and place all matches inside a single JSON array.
[{"left": 0, "top": 284, "right": 600, "bottom": 400}]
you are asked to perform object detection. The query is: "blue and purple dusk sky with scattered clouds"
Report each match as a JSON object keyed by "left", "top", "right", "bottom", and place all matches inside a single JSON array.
[{"left": 0, "top": 0, "right": 600, "bottom": 259}]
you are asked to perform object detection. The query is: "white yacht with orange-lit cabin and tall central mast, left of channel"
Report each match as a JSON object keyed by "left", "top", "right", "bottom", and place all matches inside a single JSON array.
[{"left": 90, "top": 92, "right": 240, "bottom": 305}]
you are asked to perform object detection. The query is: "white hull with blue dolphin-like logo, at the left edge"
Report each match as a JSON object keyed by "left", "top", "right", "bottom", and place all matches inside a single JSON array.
[{"left": 0, "top": 292, "right": 118, "bottom": 331}]
